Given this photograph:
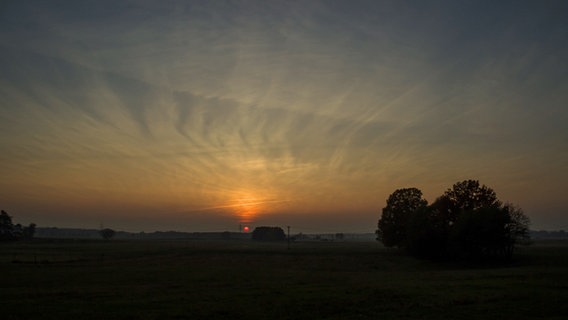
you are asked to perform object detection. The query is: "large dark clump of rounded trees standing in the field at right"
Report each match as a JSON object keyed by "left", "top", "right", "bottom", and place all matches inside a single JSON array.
[{"left": 376, "top": 180, "right": 530, "bottom": 260}]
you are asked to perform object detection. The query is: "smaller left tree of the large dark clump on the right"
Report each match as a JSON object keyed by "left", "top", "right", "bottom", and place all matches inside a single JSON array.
[{"left": 376, "top": 188, "right": 428, "bottom": 247}]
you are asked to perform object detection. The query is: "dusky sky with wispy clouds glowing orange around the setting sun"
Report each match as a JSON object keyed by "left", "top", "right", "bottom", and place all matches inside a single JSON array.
[{"left": 0, "top": 0, "right": 568, "bottom": 233}]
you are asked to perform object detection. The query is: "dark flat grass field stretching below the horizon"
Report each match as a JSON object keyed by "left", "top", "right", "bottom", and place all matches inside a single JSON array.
[{"left": 0, "top": 240, "right": 568, "bottom": 320}]
